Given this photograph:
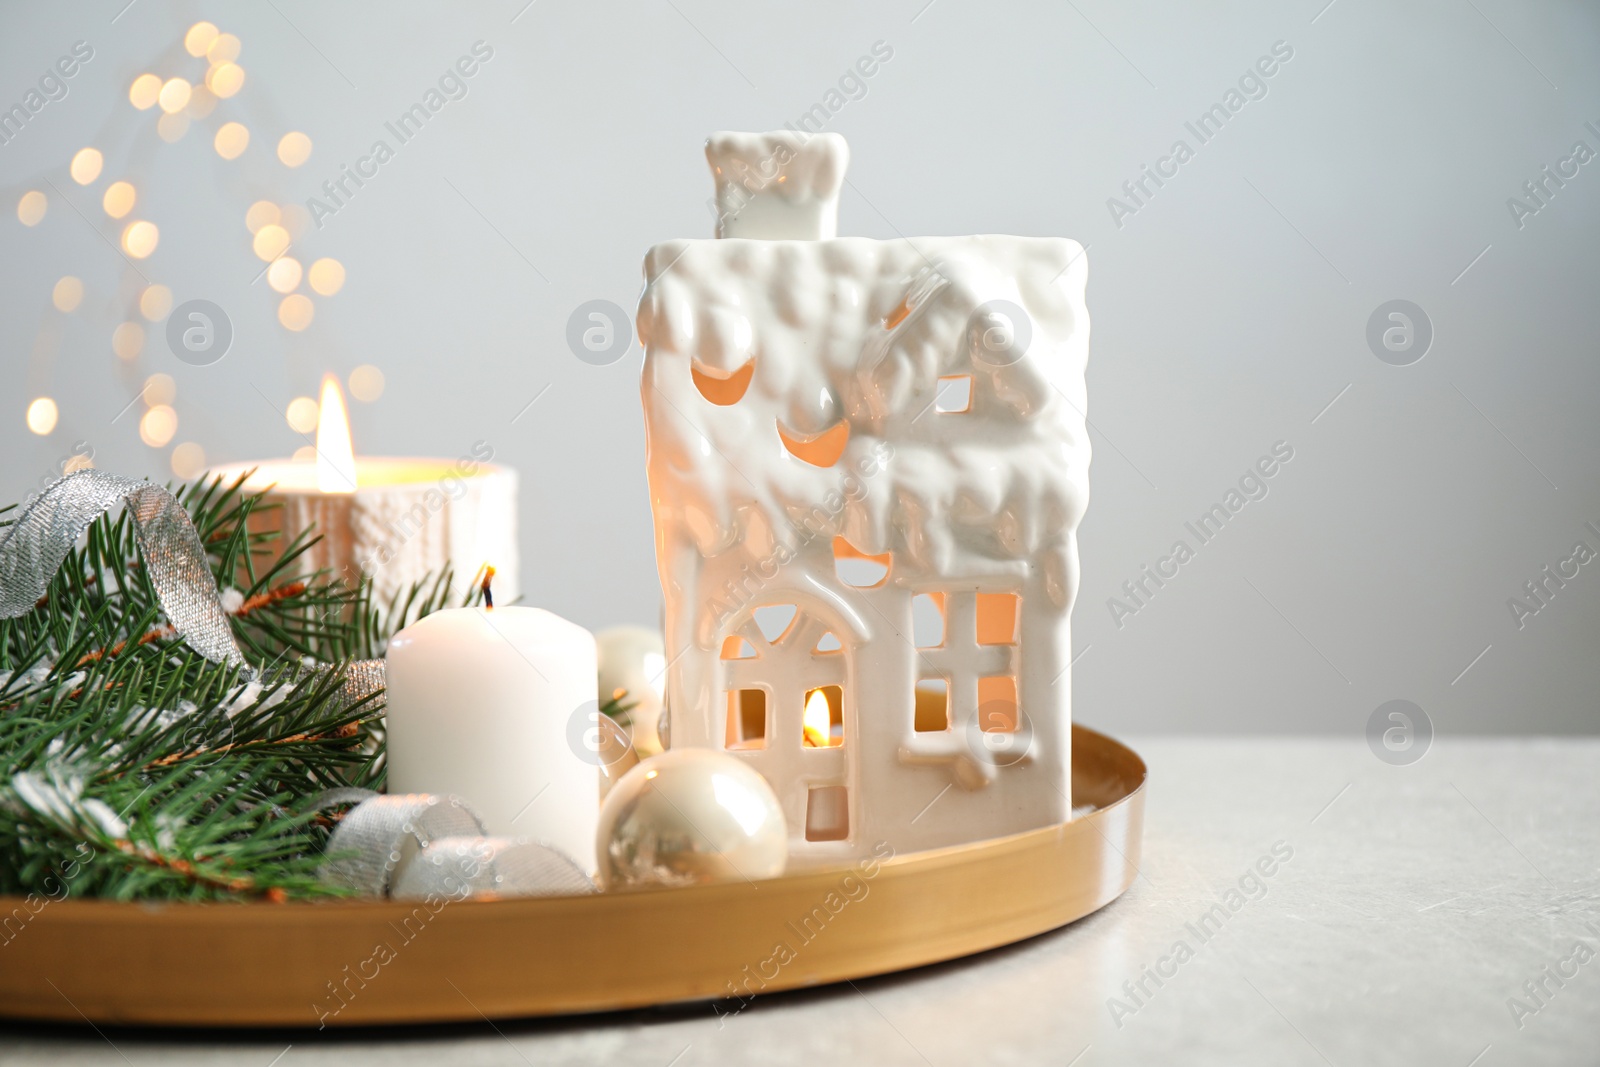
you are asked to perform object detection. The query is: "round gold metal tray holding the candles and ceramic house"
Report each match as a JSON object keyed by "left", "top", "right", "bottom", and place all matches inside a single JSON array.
[{"left": 0, "top": 726, "right": 1146, "bottom": 1027}]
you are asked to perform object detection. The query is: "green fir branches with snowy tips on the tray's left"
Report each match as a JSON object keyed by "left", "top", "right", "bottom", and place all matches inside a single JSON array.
[{"left": 0, "top": 478, "right": 475, "bottom": 901}]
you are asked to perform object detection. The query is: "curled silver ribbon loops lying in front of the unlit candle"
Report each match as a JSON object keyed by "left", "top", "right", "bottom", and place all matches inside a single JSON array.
[{"left": 315, "top": 789, "right": 595, "bottom": 901}]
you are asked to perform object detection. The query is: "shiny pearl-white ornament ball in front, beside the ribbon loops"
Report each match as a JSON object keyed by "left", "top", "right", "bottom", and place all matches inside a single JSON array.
[{"left": 595, "top": 749, "right": 789, "bottom": 889}]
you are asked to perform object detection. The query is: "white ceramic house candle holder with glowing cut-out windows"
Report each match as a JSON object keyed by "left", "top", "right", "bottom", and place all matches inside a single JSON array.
[{"left": 638, "top": 133, "right": 1090, "bottom": 865}]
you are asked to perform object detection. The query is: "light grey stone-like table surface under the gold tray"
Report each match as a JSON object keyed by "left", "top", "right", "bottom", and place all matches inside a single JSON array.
[{"left": 0, "top": 736, "right": 1600, "bottom": 1067}]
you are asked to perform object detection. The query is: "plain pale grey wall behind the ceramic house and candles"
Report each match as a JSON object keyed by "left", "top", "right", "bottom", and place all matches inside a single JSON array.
[{"left": 0, "top": 0, "right": 1600, "bottom": 739}]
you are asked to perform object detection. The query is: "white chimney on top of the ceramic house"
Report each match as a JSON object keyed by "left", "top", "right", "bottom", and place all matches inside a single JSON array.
[{"left": 706, "top": 130, "right": 850, "bottom": 242}]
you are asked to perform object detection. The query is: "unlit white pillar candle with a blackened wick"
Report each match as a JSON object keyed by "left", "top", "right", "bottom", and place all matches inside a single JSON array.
[{"left": 386, "top": 606, "right": 600, "bottom": 872}]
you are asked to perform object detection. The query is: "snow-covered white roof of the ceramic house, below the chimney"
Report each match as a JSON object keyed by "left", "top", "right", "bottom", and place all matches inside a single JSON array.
[{"left": 638, "top": 237, "right": 1090, "bottom": 573}]
